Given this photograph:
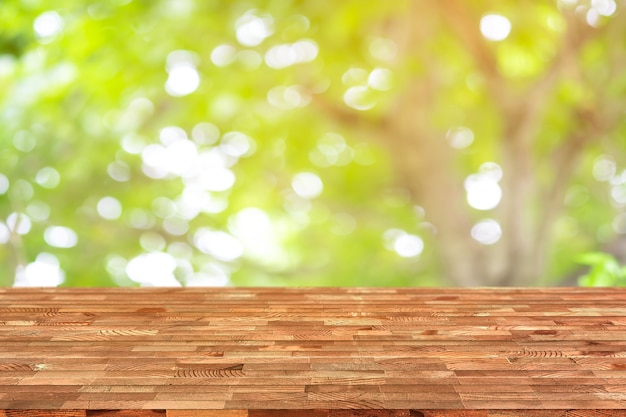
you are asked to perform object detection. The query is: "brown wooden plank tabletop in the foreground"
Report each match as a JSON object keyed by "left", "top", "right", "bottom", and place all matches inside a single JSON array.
[{"left": 0, "top": 288, "right": 626, "bottom": 417}]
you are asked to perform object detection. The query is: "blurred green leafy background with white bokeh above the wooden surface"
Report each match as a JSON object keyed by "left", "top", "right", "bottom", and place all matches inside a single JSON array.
[{"left": 0, "top": 0, "right": 626, "bottom": 286}]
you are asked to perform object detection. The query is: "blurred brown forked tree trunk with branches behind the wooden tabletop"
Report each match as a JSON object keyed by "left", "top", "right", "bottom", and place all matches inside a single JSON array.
[{"left": 370, "top": 0, "right": 600, "bottom": 286}]
